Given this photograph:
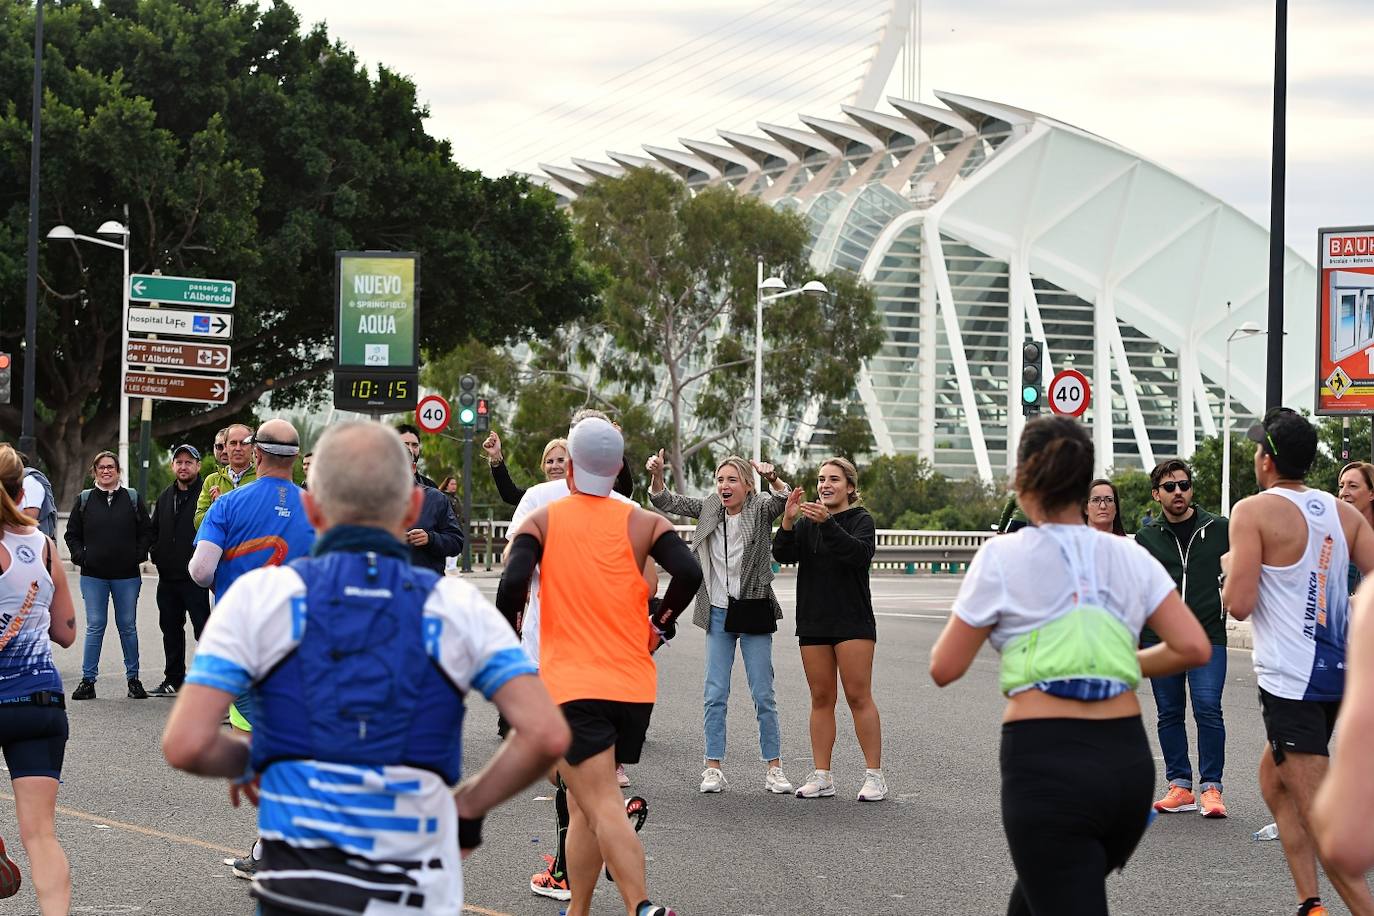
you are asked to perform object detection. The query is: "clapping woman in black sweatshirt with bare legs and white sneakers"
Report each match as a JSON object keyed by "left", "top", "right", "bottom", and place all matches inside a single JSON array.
[{"left": 772, "top": 457, "right": 888, "bottom": 802}]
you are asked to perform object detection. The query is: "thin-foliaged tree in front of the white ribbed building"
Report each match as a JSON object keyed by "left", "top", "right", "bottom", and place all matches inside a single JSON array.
[{"left": 566, "top": 169, "right": 882, "bottom": 485}]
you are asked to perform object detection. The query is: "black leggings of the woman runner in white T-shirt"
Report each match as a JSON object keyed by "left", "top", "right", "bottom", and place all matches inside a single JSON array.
[{"left": 1002, "top": 715, "right": 1154, "bottom": 916}]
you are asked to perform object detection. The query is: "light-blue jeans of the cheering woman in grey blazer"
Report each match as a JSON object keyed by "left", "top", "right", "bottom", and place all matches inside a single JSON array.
[{"left": 705, "top": 607, "right": 782, "bottom": 761}]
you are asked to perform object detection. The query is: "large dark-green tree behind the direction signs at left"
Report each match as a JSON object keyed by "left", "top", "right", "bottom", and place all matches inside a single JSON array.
[{"left": 0, "top": 0, "right": 598, "bottom": 497}]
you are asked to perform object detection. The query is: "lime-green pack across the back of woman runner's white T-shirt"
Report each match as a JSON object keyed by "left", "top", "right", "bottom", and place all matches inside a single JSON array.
[{"left": 1000, "top": 604, "right": 1140, "bottom": 696}]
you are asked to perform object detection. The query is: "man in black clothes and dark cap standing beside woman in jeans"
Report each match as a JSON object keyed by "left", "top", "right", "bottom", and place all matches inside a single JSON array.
[{"left": 148, "top": 445, "right": 210, "bottom": 696}]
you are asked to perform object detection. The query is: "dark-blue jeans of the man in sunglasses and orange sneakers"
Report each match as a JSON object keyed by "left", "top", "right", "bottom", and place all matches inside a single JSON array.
[{"left": 1150, "top": 645, "right": 1226, "bottom": 791}]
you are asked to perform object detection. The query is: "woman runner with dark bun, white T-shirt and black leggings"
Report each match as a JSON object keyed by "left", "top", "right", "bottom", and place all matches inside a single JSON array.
[{"left": 930, "top": 417, "right": 1212, "bottom": 916}]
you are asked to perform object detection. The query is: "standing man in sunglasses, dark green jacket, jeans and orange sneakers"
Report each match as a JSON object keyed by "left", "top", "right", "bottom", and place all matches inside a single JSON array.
[{"left": 1135, "top": 459, "right": 1230, "bottom": 817}]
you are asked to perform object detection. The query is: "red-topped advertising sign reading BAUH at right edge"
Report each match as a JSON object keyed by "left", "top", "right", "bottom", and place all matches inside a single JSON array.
[{"left": 1315, "top": 225, "right": 1374, "bottom": 415}]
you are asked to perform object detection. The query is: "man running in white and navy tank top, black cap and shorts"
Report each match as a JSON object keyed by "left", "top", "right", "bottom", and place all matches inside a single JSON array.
[{"left": 1221, "top": 408, "right": 1374, "bottom": 916}]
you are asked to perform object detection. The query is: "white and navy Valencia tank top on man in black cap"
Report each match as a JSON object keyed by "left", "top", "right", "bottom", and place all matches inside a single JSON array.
[{"left": 1252, "top": 486, "right": 1349, "bottom": 702}]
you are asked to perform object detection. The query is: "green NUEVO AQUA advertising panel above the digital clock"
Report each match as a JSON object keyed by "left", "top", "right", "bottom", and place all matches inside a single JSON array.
[{"left": 334, "top": 251, "right": 419, "bottom": 371}]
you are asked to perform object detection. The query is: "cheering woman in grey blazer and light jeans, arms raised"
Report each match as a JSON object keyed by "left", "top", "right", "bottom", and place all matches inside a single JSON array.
[{"left": 646, "top": 450, "right": 793, "bottom": 794}]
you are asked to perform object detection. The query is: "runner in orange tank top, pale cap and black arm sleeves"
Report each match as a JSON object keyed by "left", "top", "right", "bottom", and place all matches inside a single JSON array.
[{"left": 496, "top": 419, "right": 702, "bottom": 916}]
